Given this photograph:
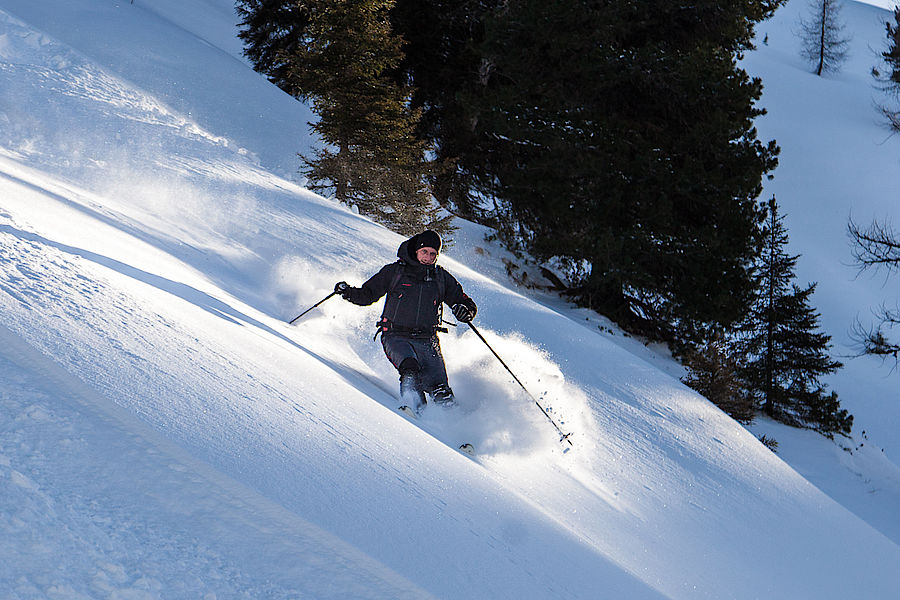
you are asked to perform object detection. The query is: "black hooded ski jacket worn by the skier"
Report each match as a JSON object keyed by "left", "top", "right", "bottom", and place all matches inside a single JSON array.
[{"left": 348, "top": 240, "right": 478, "bottom": 335}]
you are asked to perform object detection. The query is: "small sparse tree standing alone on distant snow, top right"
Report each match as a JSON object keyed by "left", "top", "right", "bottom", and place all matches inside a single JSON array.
[{"left": 800, "top": 0, "right": 850, "bottom": 76}]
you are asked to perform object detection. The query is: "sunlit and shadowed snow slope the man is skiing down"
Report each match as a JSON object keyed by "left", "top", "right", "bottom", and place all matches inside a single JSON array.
[{"left": 0, "top": 0, "right": 900, "bottom": 599}]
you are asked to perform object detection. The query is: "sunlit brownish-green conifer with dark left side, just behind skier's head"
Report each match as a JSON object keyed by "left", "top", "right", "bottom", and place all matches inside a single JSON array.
[{"left": 236, "top": 0, "right": 450, "bottom": 234}]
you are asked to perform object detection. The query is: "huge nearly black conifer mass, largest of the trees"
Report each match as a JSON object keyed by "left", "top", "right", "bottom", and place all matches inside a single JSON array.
[{"left": 458, "top": 0, "right": 780, "bottom": 338}]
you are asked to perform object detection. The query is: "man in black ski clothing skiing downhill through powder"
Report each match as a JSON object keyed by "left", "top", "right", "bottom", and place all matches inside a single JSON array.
[{"left": 334, "top": 229, "right": 478, "bottom": 414}]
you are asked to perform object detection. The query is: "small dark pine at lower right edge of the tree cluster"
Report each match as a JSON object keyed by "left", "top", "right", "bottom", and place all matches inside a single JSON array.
[{"left": 737, "top": 197, "right": 853, "bottom": 434}]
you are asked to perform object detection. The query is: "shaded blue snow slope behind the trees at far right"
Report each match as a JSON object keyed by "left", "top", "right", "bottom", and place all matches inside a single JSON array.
[{"left": 745, "top": 0, "right": 900, "bottom": 462}]
